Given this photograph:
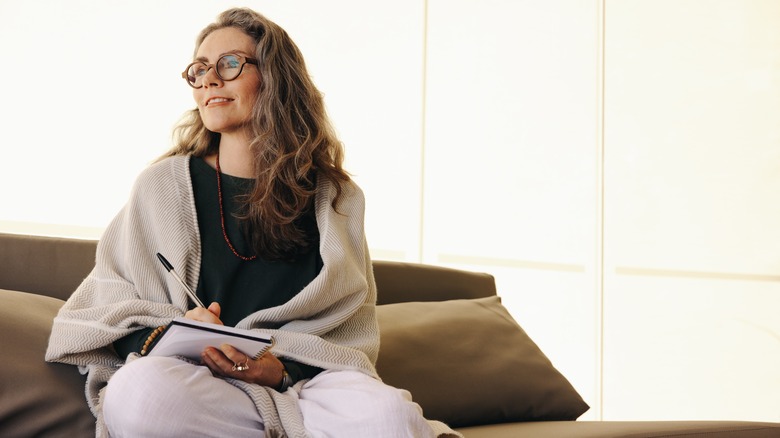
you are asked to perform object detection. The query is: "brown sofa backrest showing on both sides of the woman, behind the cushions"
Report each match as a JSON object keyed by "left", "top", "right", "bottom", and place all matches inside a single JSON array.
[{"left": 0, "top": 233, "right": 496, "bottom": 304}]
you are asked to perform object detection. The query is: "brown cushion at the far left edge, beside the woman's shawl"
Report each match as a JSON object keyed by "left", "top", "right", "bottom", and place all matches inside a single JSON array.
[{"left": 0, "top": 289, "right": 95, "bottom": 437}]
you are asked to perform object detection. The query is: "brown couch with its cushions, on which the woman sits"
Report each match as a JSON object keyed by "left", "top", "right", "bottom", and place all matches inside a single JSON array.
[{"left": 0, "top": 233, "right": 780, "bottom": 438}]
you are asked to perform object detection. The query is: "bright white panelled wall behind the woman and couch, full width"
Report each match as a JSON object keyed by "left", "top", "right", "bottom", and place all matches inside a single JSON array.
[{"left": 0, "top": 0, "right": 780, "bottom": 421}]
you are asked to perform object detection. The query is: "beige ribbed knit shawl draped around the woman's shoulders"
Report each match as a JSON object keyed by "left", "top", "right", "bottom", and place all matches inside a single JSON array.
[{"left": 46, "top": 156, "right": 458, "bottom": 437}]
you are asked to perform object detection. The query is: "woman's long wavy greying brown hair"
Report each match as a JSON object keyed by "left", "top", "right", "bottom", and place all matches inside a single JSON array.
[{"left": 164, "top": 8, "right": 350, "bottom": 260}]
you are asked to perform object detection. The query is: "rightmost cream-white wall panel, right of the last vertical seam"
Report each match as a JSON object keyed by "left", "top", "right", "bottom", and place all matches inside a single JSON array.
[{"left": 603, "top": 0, "right": 780, "bottom": 421}]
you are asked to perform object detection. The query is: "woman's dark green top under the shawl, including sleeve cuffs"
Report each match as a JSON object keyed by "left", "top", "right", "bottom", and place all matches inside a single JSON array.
[{"left": 114, "top": 157, "right": 322, "bottom": 381}]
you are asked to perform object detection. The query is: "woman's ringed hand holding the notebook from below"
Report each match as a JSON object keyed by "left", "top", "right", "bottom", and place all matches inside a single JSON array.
[{"left": 201, "top": 344, "right": 284, "bottom": 388}]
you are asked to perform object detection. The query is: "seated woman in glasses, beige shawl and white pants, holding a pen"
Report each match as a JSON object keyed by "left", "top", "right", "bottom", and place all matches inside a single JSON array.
[{"left": 46, "top": 9, "right": 454, "bottom": 437}]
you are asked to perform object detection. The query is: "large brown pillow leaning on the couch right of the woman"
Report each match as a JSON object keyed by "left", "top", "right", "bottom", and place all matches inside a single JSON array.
[{"left": 377, "top": 296, "right": 589, "bottom": 427}]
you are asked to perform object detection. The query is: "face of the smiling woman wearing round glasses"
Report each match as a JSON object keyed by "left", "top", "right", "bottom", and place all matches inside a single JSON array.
[{"left": 192, "top": 27, "right": 260, "bottom": 137}]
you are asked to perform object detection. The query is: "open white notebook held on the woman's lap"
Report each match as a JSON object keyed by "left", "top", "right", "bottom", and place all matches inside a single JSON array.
[{"left": 149, "top": 318, "right": 274, "bottom": 362}]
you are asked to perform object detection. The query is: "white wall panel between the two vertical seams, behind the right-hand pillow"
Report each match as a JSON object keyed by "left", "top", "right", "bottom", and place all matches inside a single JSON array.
[{"left": 423, "top": 0, "right": 601, "bottom": 416}]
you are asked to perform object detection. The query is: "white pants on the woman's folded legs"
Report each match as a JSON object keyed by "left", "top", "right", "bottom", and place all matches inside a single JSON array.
[{"left": 103, "top": 357, "right": 434, "bottom": 438}]
